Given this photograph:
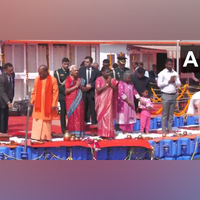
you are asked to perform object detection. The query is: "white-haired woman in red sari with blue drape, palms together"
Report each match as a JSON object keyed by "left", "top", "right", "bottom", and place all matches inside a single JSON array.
[{"left": 65, "top": 65, "right": 87, "bottom": 137}]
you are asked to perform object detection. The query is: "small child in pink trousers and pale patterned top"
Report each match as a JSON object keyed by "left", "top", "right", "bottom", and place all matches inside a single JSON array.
[{"left": 138, "top": 89, "right": 153, "bottom": 133}]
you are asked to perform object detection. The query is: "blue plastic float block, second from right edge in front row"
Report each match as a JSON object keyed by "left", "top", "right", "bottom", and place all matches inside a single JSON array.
[{"left": 177, "top": 138, "right": 191, "bottom": 157}]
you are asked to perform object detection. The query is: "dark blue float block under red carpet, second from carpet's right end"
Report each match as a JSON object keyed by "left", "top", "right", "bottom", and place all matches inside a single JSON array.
[{"left": 108, "top": 147, "right": 128, "bottom": 160}]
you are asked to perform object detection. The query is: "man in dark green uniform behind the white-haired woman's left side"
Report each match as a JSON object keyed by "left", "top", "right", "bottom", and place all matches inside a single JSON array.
[{"left": 54, "top": 58, "right": 69, "bottom": 134}]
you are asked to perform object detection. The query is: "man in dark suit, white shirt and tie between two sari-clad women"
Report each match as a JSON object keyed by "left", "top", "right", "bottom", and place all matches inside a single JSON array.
[{"left": 79, "top": 56, "right": 100, "bottom": 124}]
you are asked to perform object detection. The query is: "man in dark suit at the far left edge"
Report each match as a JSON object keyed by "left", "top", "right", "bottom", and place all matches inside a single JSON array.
[{"left": 0, "top": 63, "right": 15, "bottom": 133}]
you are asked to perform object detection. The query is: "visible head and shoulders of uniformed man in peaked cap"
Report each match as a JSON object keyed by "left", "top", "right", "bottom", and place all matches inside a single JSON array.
[{"left": 113, "top": 55, "right": 130, "bottom": 81}]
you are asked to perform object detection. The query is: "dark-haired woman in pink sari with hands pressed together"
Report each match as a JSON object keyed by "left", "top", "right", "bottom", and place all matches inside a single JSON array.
[{"left": 95, "top": 67, "right": 118, "bottom": 138}]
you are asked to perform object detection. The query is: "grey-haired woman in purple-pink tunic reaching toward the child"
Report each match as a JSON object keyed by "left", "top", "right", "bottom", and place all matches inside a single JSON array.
[{"left": 116, "top": 71, "right": 143, "bottom": 133}]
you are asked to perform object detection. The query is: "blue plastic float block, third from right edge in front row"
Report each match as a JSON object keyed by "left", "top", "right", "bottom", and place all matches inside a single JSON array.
[{"left": 159, "top": 139, "right": 177, "bottom": 158}]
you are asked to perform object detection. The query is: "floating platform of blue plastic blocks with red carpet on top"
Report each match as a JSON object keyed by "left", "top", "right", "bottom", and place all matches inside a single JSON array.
[{"left": 0, "top": 117, "right": 200, "bottom": 160}]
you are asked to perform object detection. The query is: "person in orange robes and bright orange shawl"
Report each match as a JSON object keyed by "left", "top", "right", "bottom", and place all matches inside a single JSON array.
[{"left": 31, "top": 65, "right": 59, "bottom": 141}]
